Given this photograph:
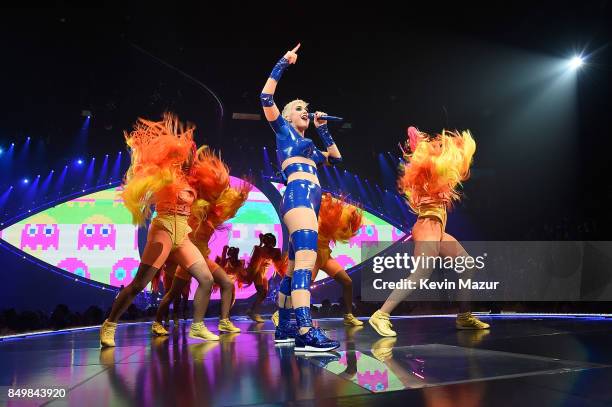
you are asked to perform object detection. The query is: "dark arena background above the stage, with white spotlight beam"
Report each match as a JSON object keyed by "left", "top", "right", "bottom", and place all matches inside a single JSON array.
[{"left": 0, "top": 1, "right": 612, "bottom": 320}]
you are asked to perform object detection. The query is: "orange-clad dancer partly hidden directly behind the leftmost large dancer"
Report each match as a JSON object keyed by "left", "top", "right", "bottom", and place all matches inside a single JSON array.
[{"left": 151, "top": 150, "right": 251, "bottom": 340}]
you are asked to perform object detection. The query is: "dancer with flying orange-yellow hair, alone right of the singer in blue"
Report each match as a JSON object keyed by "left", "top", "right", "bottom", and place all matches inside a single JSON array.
[{"left": 369, "top": 127, "right": 489, "bottom": 336}]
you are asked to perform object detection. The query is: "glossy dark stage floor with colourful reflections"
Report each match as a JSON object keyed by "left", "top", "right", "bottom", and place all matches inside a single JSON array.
[{"left": 0, "top": 315, "right": 612, "bottom": 407}]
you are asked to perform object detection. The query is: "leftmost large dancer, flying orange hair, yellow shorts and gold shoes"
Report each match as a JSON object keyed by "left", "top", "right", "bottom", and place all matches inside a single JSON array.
[{"left": 100, "top": 113, "right": 222, "bottom": 347}]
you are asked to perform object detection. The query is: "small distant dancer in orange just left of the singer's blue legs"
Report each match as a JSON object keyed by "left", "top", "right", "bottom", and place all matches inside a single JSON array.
[{"left": 244, "top": 233, "right": 287, "bottom": 323}]
